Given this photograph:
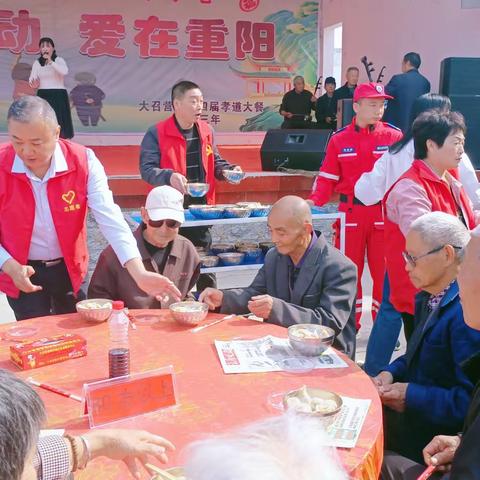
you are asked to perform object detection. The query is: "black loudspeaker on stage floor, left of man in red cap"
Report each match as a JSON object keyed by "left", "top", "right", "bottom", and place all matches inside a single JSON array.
[{"left": 260, "top": 129, "right": 331, "bottom": 171}]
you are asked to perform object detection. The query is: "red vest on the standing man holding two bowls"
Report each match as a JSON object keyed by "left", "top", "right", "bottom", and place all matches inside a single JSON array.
[{"left": 157, "top": 115, "right": 215, "bottom": 204}]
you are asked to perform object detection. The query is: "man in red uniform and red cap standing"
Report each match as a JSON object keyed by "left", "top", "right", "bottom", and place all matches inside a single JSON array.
[{"left": 310, "top": 82, "right": 402, "bottom": 329}]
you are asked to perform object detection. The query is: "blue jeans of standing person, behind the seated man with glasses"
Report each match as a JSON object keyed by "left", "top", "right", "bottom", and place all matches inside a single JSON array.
[{"left": 364, "top": 274, "right": 402, "bottom": 377}]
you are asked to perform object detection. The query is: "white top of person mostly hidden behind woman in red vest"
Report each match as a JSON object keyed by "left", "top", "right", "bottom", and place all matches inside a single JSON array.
[{"left": 355, "top": 140, "right": 480, "bottom": 210}]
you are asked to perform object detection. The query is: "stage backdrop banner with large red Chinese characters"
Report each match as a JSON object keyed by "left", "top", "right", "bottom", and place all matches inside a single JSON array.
[{"left": 0, "top": 0, "right": 318, "bottom": 133}]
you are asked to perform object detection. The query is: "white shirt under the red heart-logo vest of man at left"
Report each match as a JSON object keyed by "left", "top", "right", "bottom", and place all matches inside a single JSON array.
[{"left": 0, "top": 143, "right": 140, "bottom": 268}]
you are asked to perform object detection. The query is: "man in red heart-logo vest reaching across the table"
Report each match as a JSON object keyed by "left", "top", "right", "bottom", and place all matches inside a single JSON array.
[{"left": 0, "top": 96, "right": 180, "bottom": 320}]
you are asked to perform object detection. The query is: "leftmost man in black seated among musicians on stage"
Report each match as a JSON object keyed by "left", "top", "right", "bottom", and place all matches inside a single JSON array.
[{"left": 280, "top": 75, "right": 317, "bottom": 128}]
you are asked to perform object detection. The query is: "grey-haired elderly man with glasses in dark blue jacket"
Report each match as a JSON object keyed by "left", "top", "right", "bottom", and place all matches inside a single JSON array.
[{"left": 374, "top": 212, "right": 480, "bottom": 462}]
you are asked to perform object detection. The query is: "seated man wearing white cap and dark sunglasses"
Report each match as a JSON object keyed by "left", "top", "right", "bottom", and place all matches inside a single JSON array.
[{"left": 88, "top": 185, "right": 200, "bottom": 308}]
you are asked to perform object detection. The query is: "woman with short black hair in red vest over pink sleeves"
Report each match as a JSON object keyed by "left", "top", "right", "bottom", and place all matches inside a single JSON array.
[{"left": 384, "top": 110, "right": 476, "bottom": 340}]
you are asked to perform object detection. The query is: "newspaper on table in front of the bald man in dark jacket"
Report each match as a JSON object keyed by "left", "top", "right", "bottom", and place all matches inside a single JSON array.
[{"left": 215, "top": 335, "right": 348, "bottom": 373}]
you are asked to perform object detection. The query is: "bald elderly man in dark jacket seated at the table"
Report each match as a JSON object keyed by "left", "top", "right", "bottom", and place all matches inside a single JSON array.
[{"left": 200, "top": 196, "right": 357, "bottom": 358}]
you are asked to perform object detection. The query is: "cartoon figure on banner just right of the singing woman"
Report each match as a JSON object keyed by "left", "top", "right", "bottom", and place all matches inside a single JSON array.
[{"left": 70, "top": 72, "right": 106, "bottom": 127}]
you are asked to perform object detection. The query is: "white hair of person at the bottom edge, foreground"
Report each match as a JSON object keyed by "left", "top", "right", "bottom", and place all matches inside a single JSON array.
[{"left": 185, "top": 414, "right": 348, "bottom": 480}]
